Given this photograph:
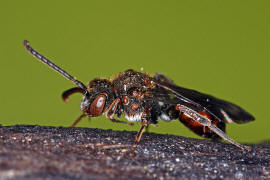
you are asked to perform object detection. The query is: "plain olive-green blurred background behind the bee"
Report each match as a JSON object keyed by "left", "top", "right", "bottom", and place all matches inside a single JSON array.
[{"left": 0, "top": 0, "right": 270, "bottom": 142}]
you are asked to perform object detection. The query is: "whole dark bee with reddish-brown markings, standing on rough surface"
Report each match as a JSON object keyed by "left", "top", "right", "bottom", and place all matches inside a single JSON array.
[{"left": 23, "top": 40, "right": 254, "bottom": 151}]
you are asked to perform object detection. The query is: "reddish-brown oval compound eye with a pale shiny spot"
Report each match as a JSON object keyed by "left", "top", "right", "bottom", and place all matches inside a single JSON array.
[{"left": 90, "top": 95, "right": 106, "bottom": 116}]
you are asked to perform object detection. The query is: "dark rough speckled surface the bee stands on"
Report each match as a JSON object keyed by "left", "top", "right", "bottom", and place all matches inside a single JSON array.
[{"left": 0, "top": 125, "right": 270, "bottom": 180}]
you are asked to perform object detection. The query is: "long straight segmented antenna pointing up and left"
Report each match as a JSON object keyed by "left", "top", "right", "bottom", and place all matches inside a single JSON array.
[{"left": 23, "top": 40, "right": 87, "bottom": 89}]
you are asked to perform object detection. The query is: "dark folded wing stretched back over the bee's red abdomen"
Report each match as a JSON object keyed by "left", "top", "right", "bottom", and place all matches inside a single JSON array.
[{"left": 154, "top": 74, "right": 255, "bottom": 123}]
